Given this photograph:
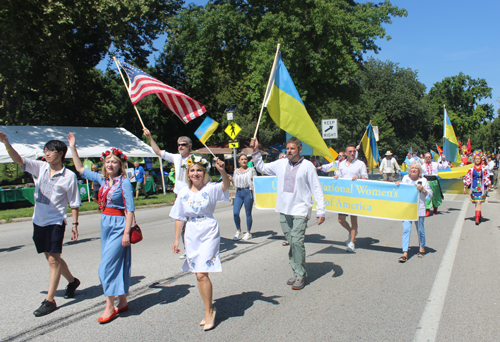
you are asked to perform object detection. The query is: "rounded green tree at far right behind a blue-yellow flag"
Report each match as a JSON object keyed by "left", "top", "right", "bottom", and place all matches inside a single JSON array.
[{"left": 428, "top": 73, "right": 494, "bottom": 141}]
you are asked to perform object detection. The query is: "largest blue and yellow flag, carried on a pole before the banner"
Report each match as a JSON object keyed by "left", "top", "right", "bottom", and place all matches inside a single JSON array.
[{"left": 264, "top": 53, "right": 332, "bottom": 158}]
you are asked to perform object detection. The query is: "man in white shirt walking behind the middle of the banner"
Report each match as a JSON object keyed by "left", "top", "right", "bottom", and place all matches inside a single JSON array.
[{"left": 334, "top": 144, "right": 368, "bottom": 252}]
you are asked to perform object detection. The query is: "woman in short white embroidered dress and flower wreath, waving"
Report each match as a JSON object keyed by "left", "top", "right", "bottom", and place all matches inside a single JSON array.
[{"left": 170, "top": 155, "right": 229, "bottom": 330}]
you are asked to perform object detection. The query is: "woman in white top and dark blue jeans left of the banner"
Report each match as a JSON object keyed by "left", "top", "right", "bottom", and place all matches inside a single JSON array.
[{"left": 229, "top": 154, "right": 257, "bottom": 240}]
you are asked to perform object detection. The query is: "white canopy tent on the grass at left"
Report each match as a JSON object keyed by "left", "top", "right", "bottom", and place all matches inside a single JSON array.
[{"left": 0, "top": 126, "right": 165, "bottom": 194}]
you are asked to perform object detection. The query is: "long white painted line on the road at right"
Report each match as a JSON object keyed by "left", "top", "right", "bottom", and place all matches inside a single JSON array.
[{"left": 413, "top": 198, "right": 469, "bottom": 342}]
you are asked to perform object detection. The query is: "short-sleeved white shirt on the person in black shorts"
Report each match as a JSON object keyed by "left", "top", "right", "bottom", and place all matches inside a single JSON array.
[{"left": 22, "top": 158, "right": 82, "bottom": 227}]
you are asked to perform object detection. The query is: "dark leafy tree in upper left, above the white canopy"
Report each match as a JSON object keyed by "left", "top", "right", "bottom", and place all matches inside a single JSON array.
[{"left": 0, "top": 0, "right": 183, "bottom": 125}]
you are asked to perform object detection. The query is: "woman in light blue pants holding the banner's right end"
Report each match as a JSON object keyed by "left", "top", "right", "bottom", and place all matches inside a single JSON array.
[{"left": 396, "top": 161, "right": 433, "bottom": 263}]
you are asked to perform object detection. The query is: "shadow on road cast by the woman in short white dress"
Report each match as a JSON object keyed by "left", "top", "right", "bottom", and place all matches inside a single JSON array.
[{"left": 214, "top": 291, "right": 281, "bottom": 324}]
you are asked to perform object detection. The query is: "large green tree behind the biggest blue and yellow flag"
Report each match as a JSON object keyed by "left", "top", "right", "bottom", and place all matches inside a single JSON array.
[{"left": 156, "top": 0, "right": 406, "bottom": 142}]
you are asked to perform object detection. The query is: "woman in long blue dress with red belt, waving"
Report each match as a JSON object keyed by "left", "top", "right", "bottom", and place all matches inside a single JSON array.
[{"left": 68, "top": 133, "right": 135, "bottom": 324}]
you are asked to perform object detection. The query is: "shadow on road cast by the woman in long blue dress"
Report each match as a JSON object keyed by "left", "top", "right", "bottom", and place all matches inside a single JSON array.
[{"left": 120, "top": 284, "right": 195, "bottom": 317}]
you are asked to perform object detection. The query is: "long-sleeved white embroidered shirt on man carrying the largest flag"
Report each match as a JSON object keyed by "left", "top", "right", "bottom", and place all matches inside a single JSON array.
[{"left": 253, "top": 152, "right": 325, "bottom": 217}]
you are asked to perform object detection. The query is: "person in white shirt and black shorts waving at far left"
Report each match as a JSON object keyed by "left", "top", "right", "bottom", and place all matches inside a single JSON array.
[{"left": 0, "top": 132, "right": 82, "bottom": 317}]
